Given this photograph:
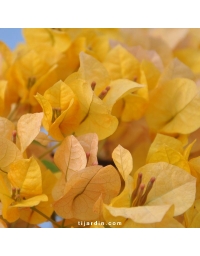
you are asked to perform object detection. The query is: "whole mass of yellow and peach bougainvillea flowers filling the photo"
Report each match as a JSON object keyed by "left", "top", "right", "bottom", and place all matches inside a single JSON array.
[{"left": 0, "top": 28, "right": 200, "bottom": 228}]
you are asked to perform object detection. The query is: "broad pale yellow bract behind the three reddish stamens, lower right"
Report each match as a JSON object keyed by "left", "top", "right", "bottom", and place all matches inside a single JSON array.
[{"left": 134, "top": 162, "right": 196, "bottom": 216}]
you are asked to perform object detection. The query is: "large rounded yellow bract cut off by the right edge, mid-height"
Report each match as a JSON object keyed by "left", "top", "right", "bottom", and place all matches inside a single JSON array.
[{"left": 146, "top": 78, "right": 200, "bottom": 135}]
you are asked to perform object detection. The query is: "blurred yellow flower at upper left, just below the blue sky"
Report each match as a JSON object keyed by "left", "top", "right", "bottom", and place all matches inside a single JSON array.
[{"left": 8, "top": 47, "right": 57, "bottom": 105}]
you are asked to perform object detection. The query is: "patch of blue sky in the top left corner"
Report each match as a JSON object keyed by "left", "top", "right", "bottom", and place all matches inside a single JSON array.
[{"left": 0, "top": 28, "right": 24, "bottom": 50}]
